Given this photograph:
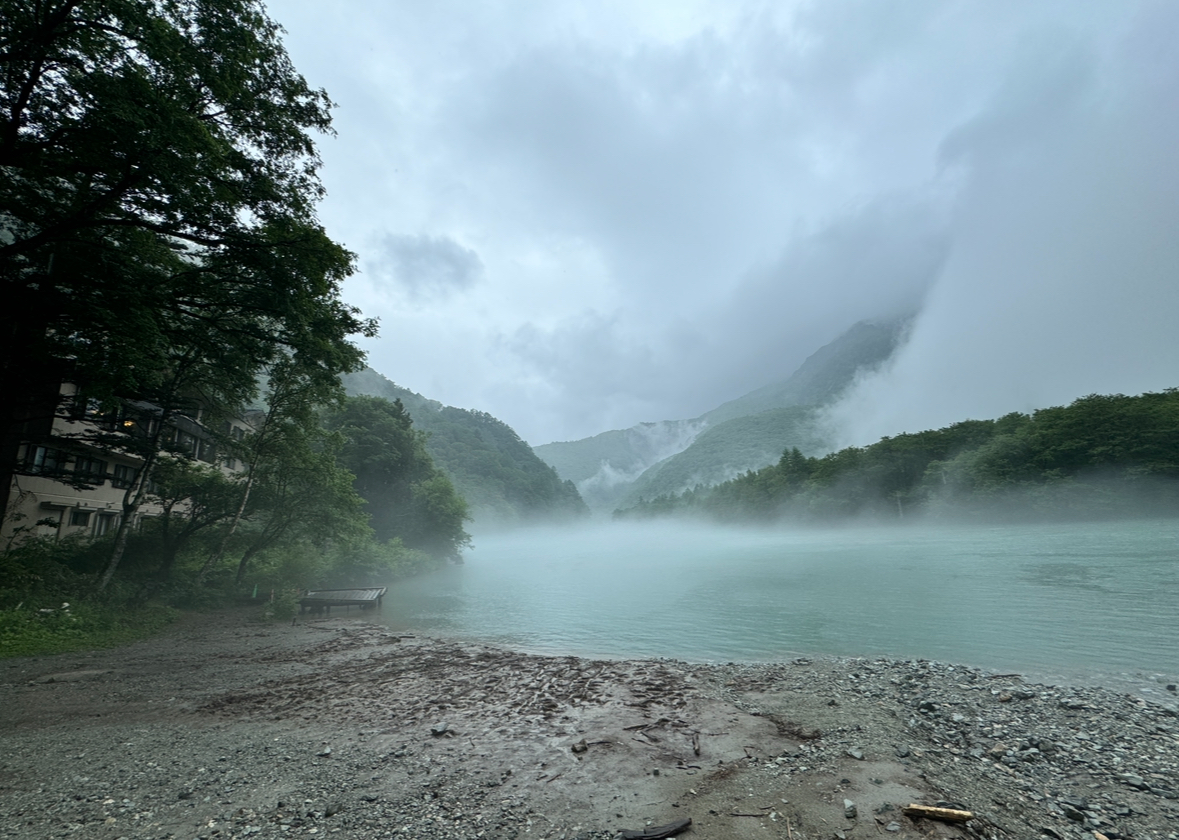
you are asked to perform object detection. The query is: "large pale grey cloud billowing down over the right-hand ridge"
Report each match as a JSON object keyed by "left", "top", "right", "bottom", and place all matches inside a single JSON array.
[{"left": 834, "top": 1, "right": 1179, "bottom": 442}]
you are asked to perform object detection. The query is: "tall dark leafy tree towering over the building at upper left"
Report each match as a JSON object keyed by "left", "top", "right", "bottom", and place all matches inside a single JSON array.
[{"left": 0, "top": 0, "right": 374, "bottom": 585}]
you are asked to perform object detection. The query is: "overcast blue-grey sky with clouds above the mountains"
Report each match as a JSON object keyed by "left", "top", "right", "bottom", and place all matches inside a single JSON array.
[{"left": 269, "top": 0, "right": 1179, "bottom": 444}]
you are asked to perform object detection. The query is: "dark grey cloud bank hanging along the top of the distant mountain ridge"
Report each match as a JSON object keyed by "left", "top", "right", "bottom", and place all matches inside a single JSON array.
[{"left": 502, "top": 198, "right": 948, "bottom": 431}]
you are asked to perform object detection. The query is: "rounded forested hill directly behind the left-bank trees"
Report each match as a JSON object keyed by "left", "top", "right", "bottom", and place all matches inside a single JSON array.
[{"left": 343, "top": 368, "right": 588, "bottom": 525}]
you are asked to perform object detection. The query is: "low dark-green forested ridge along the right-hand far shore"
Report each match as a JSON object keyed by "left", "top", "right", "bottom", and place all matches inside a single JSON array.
[{"left": 618, "top": 388, "right": 1179, "bottom": 521}]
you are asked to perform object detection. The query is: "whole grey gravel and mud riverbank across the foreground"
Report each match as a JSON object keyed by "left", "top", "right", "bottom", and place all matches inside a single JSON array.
[{"left": 0, "top": 611, "right": 1179, "bottom": 840}]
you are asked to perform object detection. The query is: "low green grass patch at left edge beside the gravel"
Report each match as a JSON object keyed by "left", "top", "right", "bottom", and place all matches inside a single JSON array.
[{"left": 0, "top": 604, "right": 180, "bottom": 658}]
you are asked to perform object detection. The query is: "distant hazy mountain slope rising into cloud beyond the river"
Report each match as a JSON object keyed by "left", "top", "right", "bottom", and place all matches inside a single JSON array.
[{"left": 535, "top": 317, "right": 909, "bottom": 511}]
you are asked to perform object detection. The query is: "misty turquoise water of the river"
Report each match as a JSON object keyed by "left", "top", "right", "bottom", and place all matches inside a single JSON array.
[{"left": 382, "top": 520, "right": 1179, "bottom": 688}]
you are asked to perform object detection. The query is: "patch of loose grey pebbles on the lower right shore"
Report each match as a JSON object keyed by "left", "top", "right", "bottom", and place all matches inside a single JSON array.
[{"left": 719, "top": 659, "right": 1179, "bottom": 840}]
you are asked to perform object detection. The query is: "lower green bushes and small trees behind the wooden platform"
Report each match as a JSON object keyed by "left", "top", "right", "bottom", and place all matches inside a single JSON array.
[{"left": 0, "top": 389, "right": 469, "bottom": 656}]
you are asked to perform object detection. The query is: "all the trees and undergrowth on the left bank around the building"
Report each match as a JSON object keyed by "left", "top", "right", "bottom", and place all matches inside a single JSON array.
[{"left": 0, "top": 0, "right": 502, "bottom": 655}]
